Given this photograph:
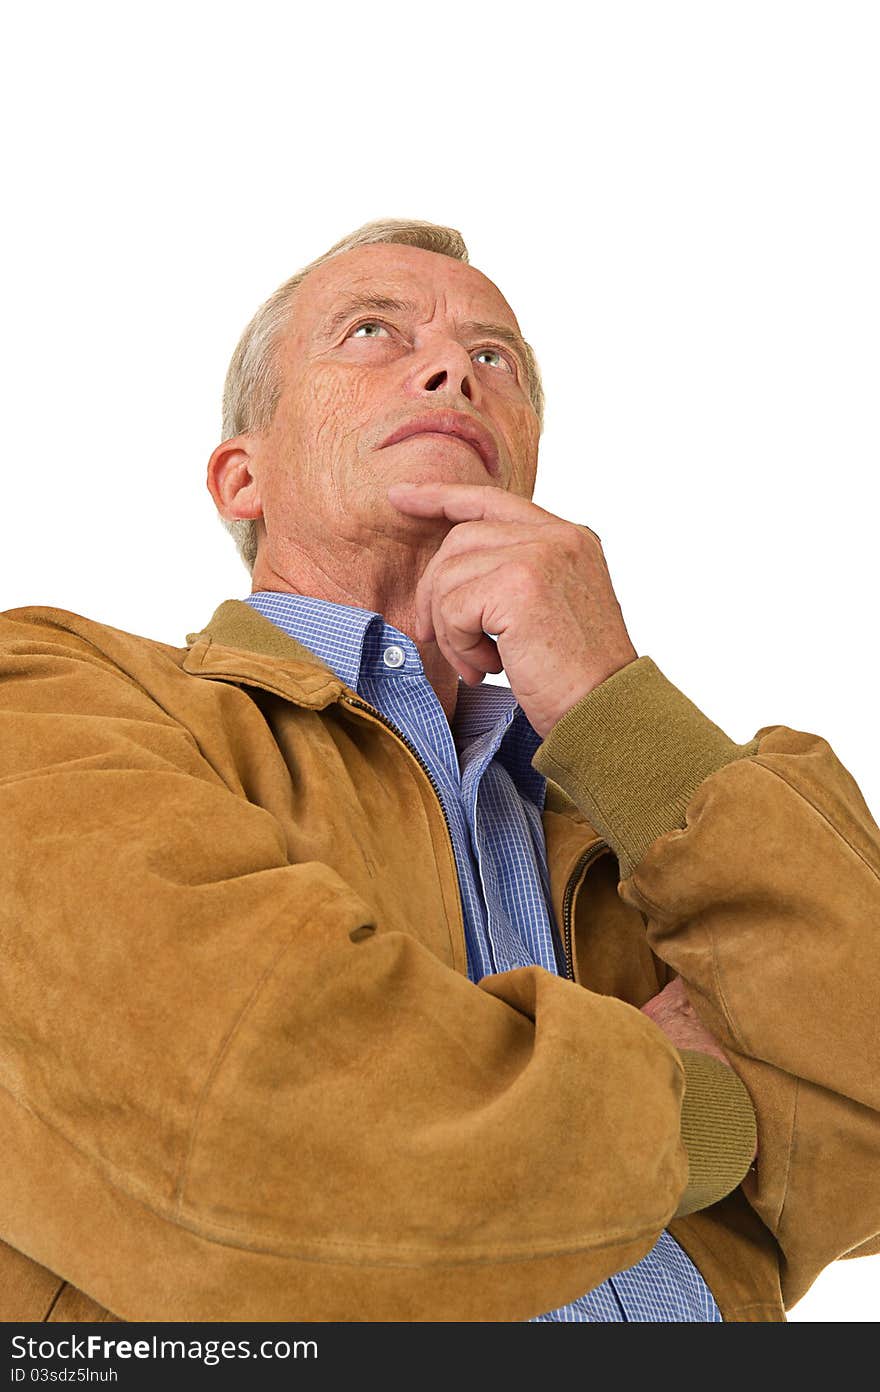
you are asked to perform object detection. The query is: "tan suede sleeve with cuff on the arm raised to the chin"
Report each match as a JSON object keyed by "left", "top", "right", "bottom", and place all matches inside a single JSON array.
[{"left": 533, "top": 657, "right": 880, "bottom": 1308}]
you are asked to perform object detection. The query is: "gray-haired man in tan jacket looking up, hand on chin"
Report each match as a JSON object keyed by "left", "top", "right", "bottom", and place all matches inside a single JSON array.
[{"left": 0, "top": 221, "right": 880, "bottom": 1321}]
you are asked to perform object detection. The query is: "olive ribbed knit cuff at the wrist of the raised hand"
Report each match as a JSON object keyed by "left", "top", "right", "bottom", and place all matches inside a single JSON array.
[{"left": 532, "top": 657, "right": 759, "bottom": 874}]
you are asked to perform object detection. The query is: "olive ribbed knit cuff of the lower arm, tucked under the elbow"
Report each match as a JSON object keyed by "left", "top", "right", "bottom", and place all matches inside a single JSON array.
[{"left": 673, "top": 1050, "right": 757, "bottom": 1218}]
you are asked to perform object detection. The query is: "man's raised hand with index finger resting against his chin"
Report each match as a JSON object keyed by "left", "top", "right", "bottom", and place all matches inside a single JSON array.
[{"left": 387, "top": 483, "right": 639, "bottom": 739}]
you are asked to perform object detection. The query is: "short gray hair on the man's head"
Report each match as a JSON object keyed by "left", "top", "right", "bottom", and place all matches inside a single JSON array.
[{"left": 214, "top": 217, "right": 544, "bottom": 575}]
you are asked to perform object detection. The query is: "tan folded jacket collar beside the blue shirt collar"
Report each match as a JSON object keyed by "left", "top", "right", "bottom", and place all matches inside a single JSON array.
[{"left": 182, "top": 600, "right": 589, "bottom": 825}]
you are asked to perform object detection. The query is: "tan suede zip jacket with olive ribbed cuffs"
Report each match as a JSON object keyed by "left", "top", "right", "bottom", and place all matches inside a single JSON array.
[{"left": 0, "top": 600, "right": 880, "bottom": 1321}]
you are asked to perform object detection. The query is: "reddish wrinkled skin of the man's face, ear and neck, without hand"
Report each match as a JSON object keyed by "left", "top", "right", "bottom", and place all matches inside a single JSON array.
[{"left": 207, "top": 245, "right": 539, "bottom": 718}]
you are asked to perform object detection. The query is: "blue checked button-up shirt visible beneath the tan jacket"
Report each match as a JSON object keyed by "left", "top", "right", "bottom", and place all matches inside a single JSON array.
[{"left": 245, "top": 590, "right": 721, "bottom": 1324}]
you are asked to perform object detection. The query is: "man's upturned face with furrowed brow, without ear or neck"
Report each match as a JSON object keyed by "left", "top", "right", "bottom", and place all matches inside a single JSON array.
[{"left": 233, "top": 245, "right": 539, "bottom": 574}]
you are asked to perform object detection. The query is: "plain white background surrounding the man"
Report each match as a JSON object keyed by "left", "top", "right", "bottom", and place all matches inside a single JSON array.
[{"left": 0, "top": 0, "right": 880, "bottom": 1321}]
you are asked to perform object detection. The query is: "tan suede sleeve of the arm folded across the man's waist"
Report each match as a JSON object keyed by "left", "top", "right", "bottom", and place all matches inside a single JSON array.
[{"left": 0, "top": 610, "right": 753, "bottom": 1321}]
